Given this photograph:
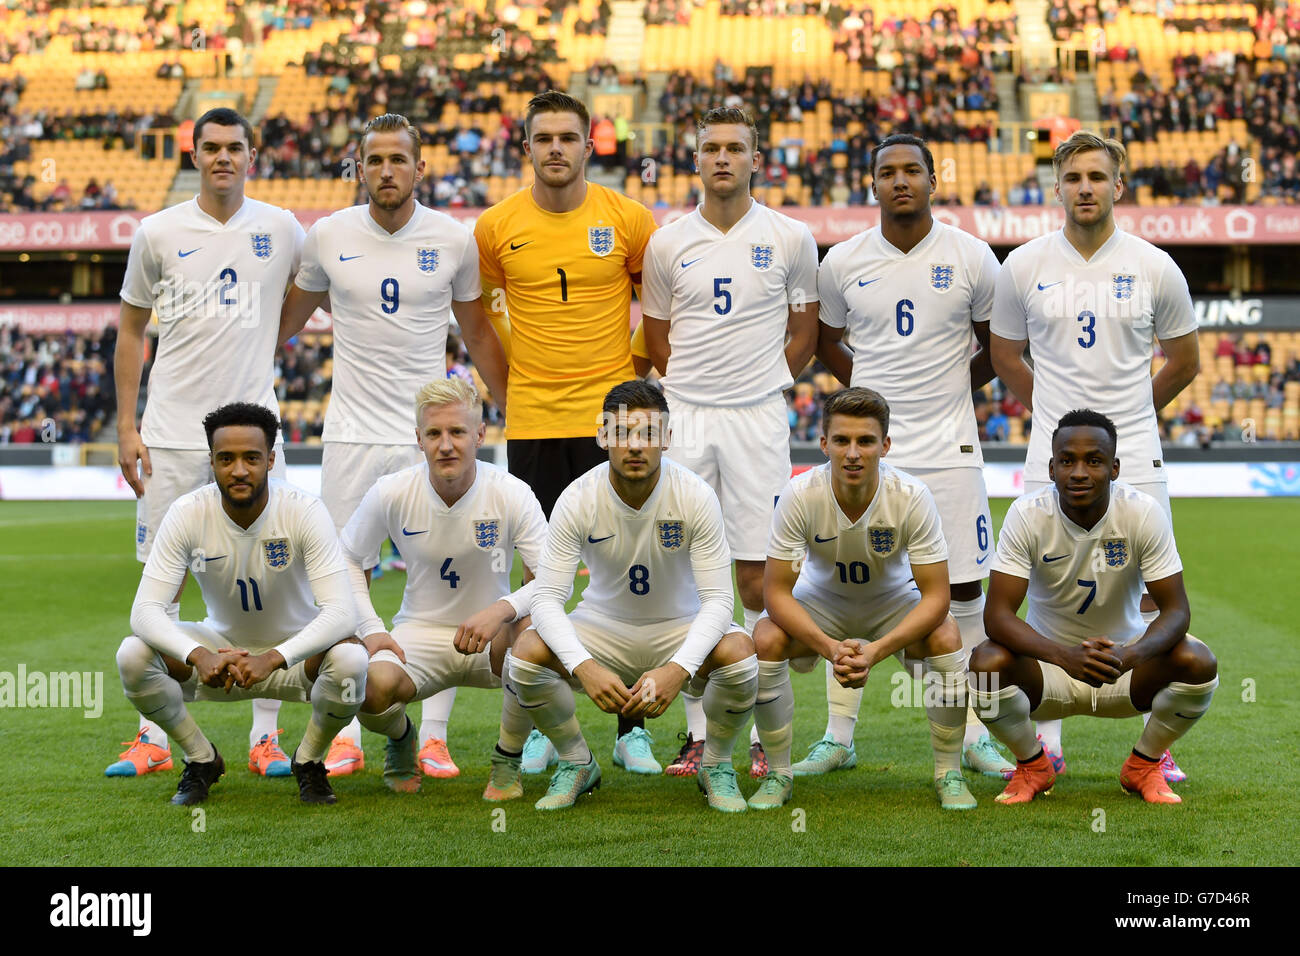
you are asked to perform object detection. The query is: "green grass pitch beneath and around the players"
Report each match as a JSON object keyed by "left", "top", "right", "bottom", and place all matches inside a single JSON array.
[{"left": 0, "top": 499, "right": 1300, "bottom": 866}]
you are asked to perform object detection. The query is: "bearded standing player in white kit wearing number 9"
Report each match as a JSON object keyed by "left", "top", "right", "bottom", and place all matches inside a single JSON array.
[{"left": 280, "top": 113, "right": 506, "bottom": 777}]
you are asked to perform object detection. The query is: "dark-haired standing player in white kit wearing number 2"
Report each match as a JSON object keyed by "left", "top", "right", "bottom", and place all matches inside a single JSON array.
[{"left": 104, "top": 109, "right": 303, "bottom": 777}]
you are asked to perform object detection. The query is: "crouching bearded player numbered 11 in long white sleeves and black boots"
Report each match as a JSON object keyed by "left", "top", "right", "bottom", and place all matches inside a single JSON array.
[{"left": 117, "top": 402, "right": 367, "bottom": 806}]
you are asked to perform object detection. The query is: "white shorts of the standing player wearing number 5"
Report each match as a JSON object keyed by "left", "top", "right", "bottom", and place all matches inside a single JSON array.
[{"left": 667, "top": 395, "right": 790, "bottom": 561}]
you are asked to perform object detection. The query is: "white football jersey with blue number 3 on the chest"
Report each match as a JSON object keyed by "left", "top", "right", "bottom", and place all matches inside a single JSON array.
[{"left": 992, "top": 229, "right": 1196, "bottom": 484}]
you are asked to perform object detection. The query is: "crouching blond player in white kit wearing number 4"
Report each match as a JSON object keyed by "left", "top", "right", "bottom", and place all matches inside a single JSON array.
[{"left": 343, "top": 378, "right": 546, "bottom": 800}]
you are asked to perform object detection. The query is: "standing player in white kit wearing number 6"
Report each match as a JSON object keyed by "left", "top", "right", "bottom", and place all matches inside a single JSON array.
[{"left": 816, "top": 133, "right": 1013, "bottom": 779}]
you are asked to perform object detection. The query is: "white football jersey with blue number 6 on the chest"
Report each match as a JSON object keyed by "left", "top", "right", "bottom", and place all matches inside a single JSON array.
[{"left": 818, "top": 220, "right": 998, "bottom": 468}]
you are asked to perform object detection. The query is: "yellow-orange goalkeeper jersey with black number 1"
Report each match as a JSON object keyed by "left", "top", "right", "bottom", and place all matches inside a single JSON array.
[{"left": 475, "top": 182, "right": 655, "bottom": 438}]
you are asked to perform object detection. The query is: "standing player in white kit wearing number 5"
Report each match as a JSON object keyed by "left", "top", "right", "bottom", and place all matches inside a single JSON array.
[{"left": 642, "top": 108, "right": 818, "bottom": 777}]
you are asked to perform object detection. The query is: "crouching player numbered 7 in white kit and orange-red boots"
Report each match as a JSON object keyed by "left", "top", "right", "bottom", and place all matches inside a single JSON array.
[{"left": 970, "top": 410, "right": 1218, "bottom": 804}]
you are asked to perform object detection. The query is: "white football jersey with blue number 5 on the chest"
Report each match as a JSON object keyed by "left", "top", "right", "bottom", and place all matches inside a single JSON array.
[{"left": 641, "top": 202, "right": 816, "bottom": 406}]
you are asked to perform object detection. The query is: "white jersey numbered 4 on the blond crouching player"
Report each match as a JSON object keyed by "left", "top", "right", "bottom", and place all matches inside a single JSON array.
[{"left": 342, "top": 462, "right": 546, "bottom": 628}]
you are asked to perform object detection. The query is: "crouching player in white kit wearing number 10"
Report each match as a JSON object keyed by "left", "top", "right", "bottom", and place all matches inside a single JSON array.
[{"left": 749, "top": 388, "right": 975, "bottom": 810}]
